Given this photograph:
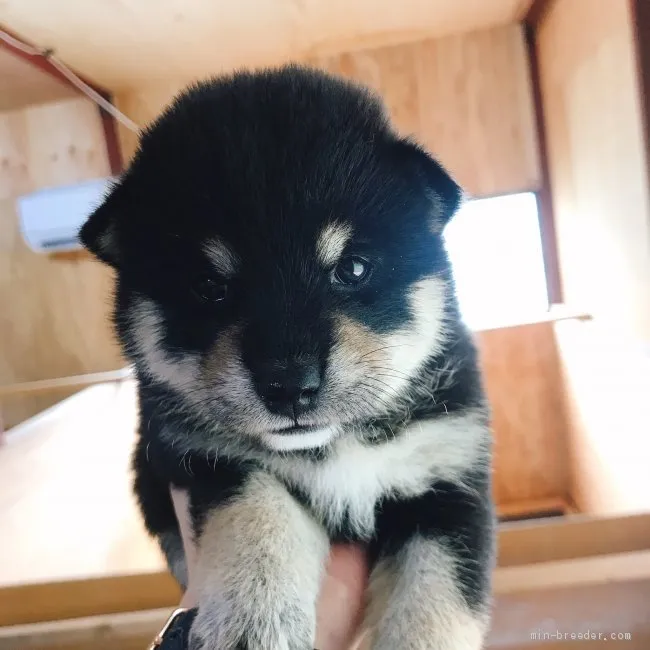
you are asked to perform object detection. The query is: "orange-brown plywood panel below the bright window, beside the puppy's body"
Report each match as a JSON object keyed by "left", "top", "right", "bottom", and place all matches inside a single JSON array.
[{"left": 478, "top": 323, "right": 569, "bottom": 504}]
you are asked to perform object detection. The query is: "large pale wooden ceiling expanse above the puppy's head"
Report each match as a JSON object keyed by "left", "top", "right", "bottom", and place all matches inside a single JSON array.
[{"left": 0, "top": 0, "right": 532, "bottom": 90}]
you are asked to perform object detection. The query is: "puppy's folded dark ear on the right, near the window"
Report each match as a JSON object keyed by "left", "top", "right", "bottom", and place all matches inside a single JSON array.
[{"left": 397, "top": 139, "right": 465, "bottom": 233}]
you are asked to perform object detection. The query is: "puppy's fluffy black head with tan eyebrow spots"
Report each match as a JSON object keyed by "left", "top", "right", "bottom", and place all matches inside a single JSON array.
[{"left": 81, "top": 67, "right": 460, "bottom": 450}]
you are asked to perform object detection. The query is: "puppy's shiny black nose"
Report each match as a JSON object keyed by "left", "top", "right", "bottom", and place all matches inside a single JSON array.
[{"left": 255, "top": 358, "right": 321, "bottom": 420}]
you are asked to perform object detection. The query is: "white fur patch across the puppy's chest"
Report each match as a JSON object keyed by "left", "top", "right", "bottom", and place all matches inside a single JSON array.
[{"left": 264, "top": 412, "right": 489, "bottom": 537}]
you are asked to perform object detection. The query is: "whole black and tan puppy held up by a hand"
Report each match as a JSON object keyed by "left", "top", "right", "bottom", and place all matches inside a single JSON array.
[{"left": 81, "top": 67, "right": 493, "bottom": 650}]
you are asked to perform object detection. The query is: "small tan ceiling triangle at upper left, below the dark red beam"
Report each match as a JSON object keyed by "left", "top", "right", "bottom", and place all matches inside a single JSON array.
[{"left": 0, "top": 48, "right": 77, "bottom": 111}]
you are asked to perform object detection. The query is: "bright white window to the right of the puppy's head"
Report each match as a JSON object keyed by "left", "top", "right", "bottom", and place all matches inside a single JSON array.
[{"left": 445, "top": 193, "right": 548, "bottom": 329}]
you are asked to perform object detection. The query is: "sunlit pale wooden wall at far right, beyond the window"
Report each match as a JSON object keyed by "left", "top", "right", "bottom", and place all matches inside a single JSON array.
[{"left": 537, "top": 0, "right": 650, "bottom": 514}]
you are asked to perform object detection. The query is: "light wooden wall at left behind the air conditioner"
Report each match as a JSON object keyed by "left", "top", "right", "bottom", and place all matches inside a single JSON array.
[{"left": 0, "top": 99, "right": 121, "bottom": 427}]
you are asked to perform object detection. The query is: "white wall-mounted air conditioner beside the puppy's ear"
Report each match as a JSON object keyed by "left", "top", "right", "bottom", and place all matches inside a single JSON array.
[{"left": 17, "top": 178, "right": 115, "bottom": 253}]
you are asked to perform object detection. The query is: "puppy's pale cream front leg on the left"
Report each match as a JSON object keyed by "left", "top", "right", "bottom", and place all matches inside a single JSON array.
[{"left": 190, "top": 473, "right": 329, "bottom": 650}]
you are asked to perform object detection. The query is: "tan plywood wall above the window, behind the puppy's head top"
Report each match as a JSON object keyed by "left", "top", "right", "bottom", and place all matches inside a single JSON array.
[{"left": 117, "top": 25, "right": 540, "bottom": 196}]
